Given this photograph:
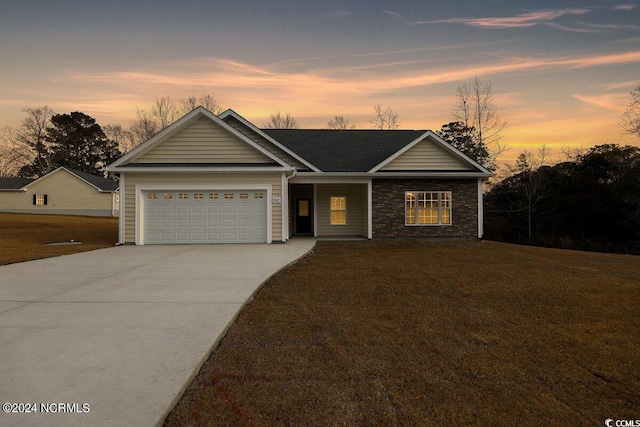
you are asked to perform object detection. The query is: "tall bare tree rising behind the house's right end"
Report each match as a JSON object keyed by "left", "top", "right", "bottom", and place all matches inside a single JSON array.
[{"left": 453, "top": 77, "right": 507, "bottom": 163}]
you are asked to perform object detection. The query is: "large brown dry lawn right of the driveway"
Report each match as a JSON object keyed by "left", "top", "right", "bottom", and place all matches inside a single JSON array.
[{"left": 165, "top": 241, "right": 640, "bottom": 426}]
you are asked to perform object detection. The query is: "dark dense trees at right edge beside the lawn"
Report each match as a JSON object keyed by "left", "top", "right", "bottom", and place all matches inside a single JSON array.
[{"left": 485, "top": 144, "right": 640, "bottom": 254}]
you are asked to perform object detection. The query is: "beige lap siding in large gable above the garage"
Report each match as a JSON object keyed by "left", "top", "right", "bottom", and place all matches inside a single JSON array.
[{"left": 134, "top": 118, "right": 274, "bottom": 163}]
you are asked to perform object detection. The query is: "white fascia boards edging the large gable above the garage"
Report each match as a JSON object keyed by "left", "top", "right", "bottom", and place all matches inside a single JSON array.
[{"left": 106, "top": 107, "right": 290, "bottom": 172}]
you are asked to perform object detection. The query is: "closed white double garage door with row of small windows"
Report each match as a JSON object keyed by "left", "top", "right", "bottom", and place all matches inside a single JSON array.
[{"left": 143, "top": 190, "right": 267, "bottom": 244}]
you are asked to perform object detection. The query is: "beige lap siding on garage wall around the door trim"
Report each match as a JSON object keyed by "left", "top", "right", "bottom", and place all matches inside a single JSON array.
[{"left": 124, "top": 173, "right": 286, "bottom": 243}]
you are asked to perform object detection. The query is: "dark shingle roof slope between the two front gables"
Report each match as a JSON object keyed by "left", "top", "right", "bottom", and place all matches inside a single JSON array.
[{"left": 262, "top": 129, "right": 426, "bottom": 172}]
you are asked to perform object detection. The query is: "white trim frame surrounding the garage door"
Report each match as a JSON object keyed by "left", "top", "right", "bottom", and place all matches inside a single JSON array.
[{"left": 135, "top": 184, "right": 273, "bottom": 245}]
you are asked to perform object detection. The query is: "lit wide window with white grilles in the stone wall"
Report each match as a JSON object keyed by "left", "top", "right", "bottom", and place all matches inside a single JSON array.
[{"left": 404, "top": 191, "right": 451, "bottom": 225}]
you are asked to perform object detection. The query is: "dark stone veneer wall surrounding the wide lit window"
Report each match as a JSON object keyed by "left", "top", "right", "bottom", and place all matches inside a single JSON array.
[{"left": 372, "top": 179, "right": 478, "bottom": 239}]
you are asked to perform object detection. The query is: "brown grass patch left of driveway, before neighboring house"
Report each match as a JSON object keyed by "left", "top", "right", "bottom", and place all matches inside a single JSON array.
[{"left": 0, "top": 213, "right": 118, "bottom": 265}]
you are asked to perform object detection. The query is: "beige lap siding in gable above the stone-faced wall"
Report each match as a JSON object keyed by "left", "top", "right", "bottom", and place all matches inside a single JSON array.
[{"left": 380, "top": 139, "right": 472, "bottom": 171}]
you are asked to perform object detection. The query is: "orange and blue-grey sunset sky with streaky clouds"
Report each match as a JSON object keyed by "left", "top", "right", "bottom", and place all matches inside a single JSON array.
[{"left": 0, "top": 0, "right": 640, "bottom": 164}]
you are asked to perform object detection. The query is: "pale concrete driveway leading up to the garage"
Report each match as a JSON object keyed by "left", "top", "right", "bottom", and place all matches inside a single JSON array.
[{"left": 0, "top": 239, "right": 315, "bottom": 426}]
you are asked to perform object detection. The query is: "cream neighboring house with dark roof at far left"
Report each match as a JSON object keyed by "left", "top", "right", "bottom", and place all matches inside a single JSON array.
[{"left": 0, "top": 167, "right": 120, "bottom": 216}]
